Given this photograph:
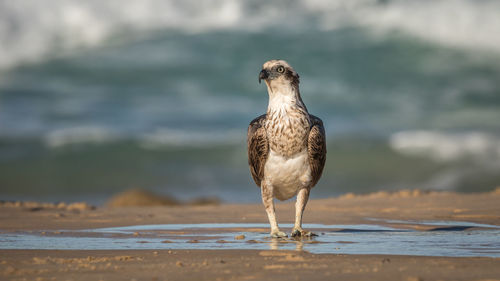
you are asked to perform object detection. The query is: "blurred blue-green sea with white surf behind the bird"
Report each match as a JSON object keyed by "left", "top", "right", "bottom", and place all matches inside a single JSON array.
[{"left": 0, "top": 0, "right": 500, "bottom": 204}]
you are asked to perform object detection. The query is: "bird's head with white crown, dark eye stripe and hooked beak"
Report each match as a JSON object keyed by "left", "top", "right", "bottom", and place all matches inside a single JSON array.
[{"left": 259, "top": 60, "right": 299, "bottom": 93}]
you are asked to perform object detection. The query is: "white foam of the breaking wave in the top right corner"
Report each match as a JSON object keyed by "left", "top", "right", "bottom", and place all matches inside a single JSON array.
[{"left": 360, "top": 0, "right": 500, "bottom": 51}]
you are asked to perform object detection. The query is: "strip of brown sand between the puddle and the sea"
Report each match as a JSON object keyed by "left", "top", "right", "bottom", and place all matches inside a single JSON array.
[{"left": 0, "top": 188, "right": 500, "bottom": 231}]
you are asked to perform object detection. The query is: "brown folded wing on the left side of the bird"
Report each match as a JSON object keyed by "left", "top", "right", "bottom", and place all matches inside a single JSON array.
[{"left": 247, "top": 114, "right": 269, "bottom": 187}]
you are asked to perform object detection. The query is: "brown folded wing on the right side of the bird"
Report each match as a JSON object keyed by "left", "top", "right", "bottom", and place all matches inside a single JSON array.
[{"left": 307, "top": 115, "right": 326, "bottom": 186}]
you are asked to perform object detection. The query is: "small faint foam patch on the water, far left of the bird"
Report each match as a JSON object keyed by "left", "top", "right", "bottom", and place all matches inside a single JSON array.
[{"left": 44, "top": 126, "right": 117, "bottom": 148}]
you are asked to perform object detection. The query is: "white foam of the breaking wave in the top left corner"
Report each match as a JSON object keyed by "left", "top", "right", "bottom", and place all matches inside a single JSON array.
[{"left": 0, "top": 0, "right": 241, "bottom": 68}]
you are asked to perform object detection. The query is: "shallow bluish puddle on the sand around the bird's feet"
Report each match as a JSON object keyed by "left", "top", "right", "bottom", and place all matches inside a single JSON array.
[{"left": 0, "top": 221, "right": 500, "bottom": 257}]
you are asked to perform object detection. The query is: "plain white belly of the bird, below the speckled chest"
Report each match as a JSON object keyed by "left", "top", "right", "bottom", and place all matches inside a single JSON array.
[{"left": 264, "top": 149, "right": 311, "bottom": 200}]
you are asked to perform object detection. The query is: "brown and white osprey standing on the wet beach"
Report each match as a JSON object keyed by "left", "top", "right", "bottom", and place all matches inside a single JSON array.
[{"left": 247, "top": 60, "right": 326, "bottom": 238}]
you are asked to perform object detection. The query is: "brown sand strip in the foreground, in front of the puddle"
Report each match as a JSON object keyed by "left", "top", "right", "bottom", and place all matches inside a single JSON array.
[{"left": 0, "top": 250, "right": 500, "bottom": 281}]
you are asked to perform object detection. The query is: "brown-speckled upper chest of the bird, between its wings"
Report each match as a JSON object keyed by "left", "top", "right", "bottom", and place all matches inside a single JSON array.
[{"left": 265, "top": 106, "right": 310, "bottom": 157}]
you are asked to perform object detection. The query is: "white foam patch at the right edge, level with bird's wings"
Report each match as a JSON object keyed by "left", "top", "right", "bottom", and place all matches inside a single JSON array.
[{"left": 389, "top": 131, "right": 500, "bottom": 163}]
